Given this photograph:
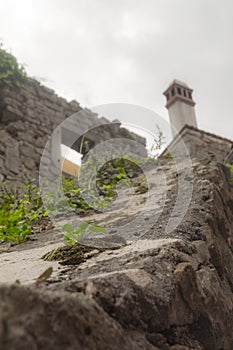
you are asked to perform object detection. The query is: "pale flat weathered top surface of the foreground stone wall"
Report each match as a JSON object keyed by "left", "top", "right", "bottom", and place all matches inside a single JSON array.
[{"left": 0, "top": 159, "right": 184, "bottom": 284}]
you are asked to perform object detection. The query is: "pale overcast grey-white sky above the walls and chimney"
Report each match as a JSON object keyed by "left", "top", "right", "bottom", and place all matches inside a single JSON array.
[{"left": 0, "top": 0, "right": 233, "bottom": 139}]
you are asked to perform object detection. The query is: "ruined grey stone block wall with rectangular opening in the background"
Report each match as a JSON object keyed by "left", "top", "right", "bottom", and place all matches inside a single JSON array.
[{"left": 0, "top": 79, "right": 146, "bottom": 185}]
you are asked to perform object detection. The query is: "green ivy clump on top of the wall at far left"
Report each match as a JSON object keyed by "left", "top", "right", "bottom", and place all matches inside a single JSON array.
[{"left": 0, "top": 43, "right": 27, "bottom": 92}]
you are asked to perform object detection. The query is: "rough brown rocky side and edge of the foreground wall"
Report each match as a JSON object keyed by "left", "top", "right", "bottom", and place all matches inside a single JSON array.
[{"left": 0, "top": 149, "right": 233, "bottom": 350}]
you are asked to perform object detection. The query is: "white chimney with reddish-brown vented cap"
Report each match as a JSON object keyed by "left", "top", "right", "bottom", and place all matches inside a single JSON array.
[{"left": 163, "top": 80, "right": 197, "bottom": 137}]
